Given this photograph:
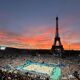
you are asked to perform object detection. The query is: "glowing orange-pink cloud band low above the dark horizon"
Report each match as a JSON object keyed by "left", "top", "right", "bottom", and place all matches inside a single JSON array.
[{"left": 0, "top": 25, "right": 80, "bottom": 50}]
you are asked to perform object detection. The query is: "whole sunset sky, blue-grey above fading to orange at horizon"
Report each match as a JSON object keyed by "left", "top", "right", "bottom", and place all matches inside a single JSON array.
[{"left": 0, "top": 0, "right": 80, "bottom": 50}]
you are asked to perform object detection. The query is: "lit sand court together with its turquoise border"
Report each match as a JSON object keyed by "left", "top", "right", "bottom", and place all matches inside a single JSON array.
[{"left": 16, "top": 60, "right": 61, "bottom": 80}]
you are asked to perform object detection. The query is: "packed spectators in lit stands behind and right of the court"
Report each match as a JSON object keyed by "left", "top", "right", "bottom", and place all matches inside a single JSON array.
[{"left": 0, "top": 51, "right": 80, "bottom": 80}]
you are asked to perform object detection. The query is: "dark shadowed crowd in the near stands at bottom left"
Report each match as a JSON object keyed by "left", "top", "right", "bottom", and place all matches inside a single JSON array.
[{"left": 0, "top": 70, "right": 49, "bottom": 80}]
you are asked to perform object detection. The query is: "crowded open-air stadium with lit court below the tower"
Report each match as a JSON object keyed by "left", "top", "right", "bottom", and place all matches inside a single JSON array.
[{"left": 0, "top": 49, "right": 80, "bottom": 80}]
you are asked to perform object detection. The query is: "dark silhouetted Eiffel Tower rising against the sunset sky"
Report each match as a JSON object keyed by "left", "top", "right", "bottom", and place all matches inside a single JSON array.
[{"left": 51, "top": 17, "right": 64, "bottom": 56}]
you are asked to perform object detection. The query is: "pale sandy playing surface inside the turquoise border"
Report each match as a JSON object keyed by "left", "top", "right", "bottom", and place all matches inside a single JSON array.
[{"left": 23, "top": 64, "right": 53, "bottom": 76}]
